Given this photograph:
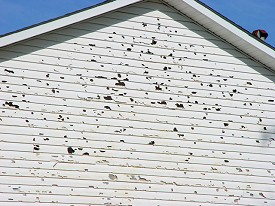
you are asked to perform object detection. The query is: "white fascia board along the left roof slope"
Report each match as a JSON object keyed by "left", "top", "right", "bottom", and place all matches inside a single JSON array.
[{"left": 0, "top": 0, "right": 142, "bottom": 48}]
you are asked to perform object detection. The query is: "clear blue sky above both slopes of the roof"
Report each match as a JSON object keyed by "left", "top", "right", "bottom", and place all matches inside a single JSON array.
[{"left": 0, "top": 0, "right": 275, "bottom": 47}]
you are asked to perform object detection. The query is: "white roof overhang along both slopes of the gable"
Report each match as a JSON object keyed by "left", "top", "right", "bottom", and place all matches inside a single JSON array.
[{"left": 0, "top": 0, "right": 275, "bottom": 71}]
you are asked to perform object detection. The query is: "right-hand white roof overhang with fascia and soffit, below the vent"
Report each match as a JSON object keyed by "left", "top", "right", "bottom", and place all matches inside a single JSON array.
[{"left": 163, "top": 0, "right": 275, "bottom": 71}]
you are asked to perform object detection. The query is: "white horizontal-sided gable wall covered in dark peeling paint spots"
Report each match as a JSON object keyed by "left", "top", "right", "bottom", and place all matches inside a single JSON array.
[{"left": 0, "top": 1, "right": 275, "bottom": 206}]
